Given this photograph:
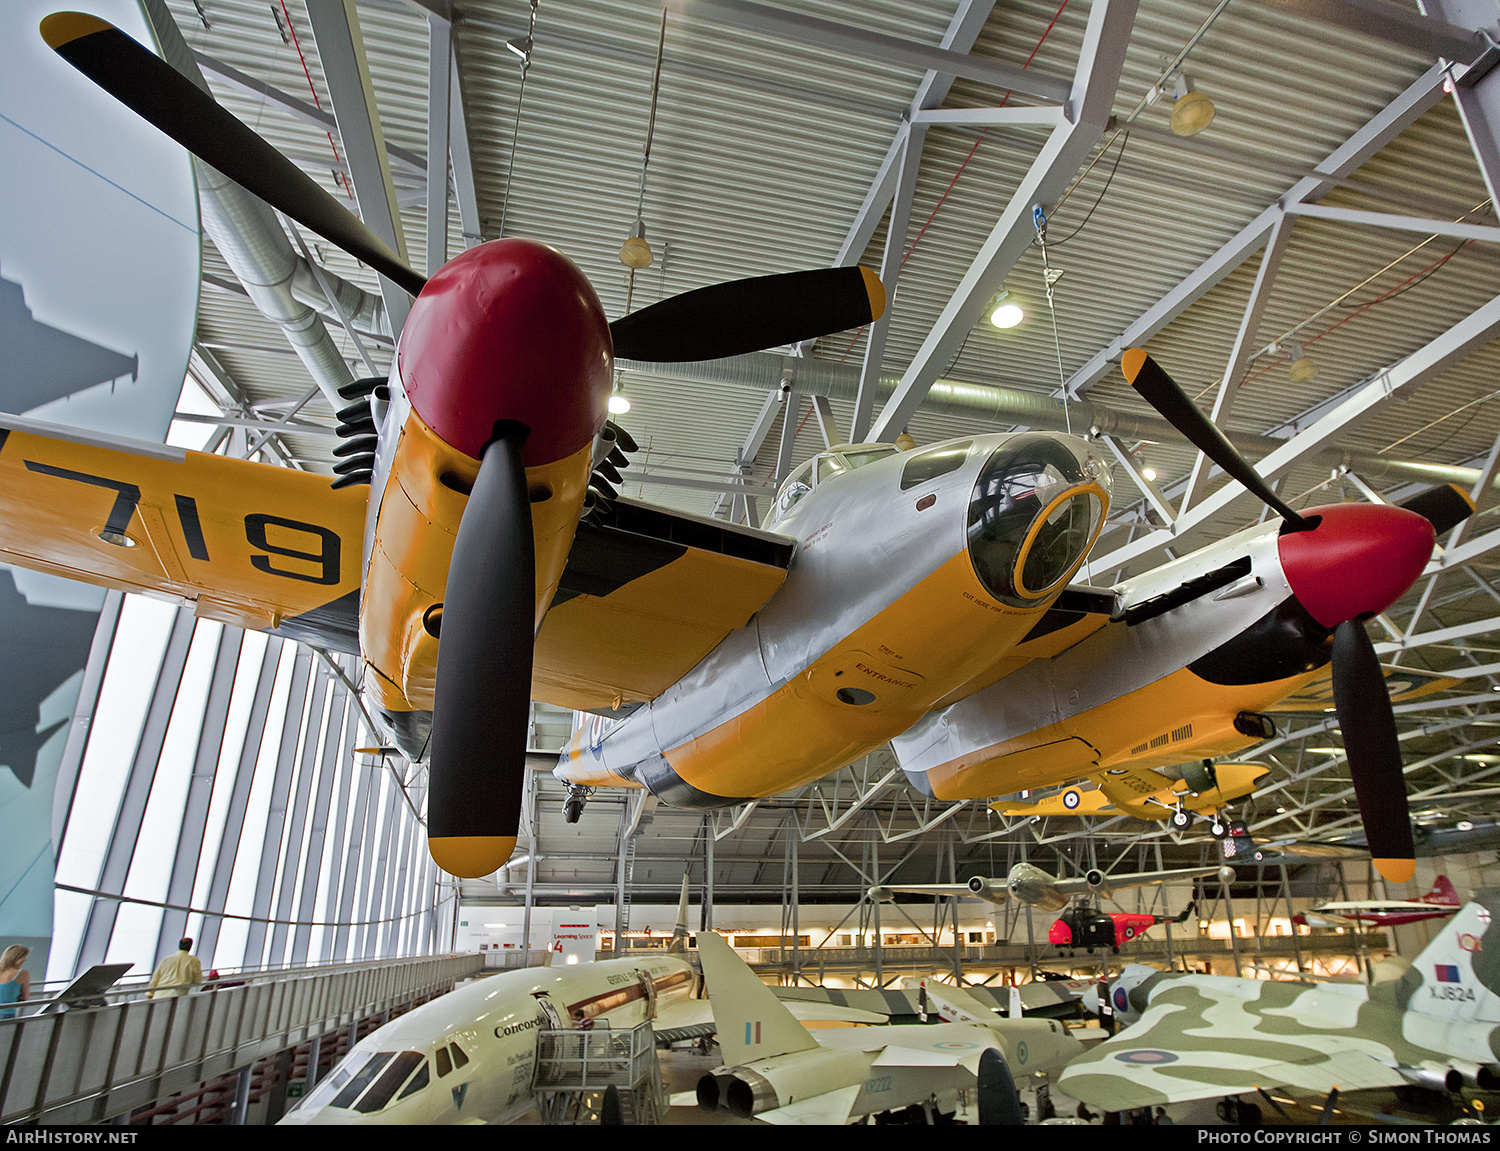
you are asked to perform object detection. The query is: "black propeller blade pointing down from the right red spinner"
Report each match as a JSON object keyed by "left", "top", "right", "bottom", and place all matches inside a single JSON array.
[{"left": 1334, "top": 620, "right": 1416, "bottom": 882}]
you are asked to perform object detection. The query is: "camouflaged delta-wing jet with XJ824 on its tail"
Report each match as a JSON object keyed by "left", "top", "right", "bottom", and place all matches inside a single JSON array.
[{"left": 1058, "top": 888, "right": 1500, "bottom": 1110}]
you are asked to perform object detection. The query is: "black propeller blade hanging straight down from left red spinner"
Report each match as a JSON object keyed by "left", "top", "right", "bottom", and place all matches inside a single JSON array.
[{"left": 428, "top": 420, "right": 537, "bottom": 878}]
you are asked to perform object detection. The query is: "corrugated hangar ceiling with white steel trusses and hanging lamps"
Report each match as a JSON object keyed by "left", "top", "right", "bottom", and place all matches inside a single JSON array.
[{"left": 143, "top": 0, "right": 1500, "bottom": 899}]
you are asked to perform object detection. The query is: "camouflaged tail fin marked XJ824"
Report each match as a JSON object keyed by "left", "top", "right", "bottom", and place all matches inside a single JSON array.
[{"left": 1406, "top": 888, "right": 1500, "bottom": 1023}]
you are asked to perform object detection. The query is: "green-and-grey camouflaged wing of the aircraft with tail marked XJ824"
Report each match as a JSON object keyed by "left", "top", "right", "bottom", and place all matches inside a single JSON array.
[{"left": 1058, "top": 984, "right": 1407, "bottom": 1110}]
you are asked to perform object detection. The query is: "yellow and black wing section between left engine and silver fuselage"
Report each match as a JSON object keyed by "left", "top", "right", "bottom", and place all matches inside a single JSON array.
[{"left": 531, "top": 498, "right": 797, "bottom": 711}]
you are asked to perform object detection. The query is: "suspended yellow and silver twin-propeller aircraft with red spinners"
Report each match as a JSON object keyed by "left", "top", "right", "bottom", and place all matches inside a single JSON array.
[{"left": 29, "top": 14, "right": 1470, "bottom": 879}]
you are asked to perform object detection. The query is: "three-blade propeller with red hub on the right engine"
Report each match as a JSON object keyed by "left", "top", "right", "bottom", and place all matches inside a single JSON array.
[{"left": 1121, "top": 348, "right": 1473, "bottom": 882}]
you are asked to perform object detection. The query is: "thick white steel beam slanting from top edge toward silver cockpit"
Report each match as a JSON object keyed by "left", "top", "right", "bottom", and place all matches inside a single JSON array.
[{"left": 873, "top": 0, "right": 1137, "bottom": 440}]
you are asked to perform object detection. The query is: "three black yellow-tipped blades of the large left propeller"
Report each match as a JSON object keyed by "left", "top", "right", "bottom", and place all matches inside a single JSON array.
[{"left": 41, "top": 12, "right": 885, "bottom": 875}]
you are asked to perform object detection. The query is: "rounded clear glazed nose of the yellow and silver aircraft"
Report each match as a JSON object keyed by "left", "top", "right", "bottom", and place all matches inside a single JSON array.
[{"left": 969, "top": 435, "right": 1104, "bottom": 608}]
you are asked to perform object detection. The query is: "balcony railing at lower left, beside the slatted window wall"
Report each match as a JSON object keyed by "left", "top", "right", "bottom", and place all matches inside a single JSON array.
[{"left": 0, "top": 954, "right": 485, "bottom": 1124}]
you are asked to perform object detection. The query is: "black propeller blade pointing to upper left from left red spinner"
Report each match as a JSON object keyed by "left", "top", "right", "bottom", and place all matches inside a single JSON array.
[{"left": 42, "top": 12, "right": 426, "bottom": 296}]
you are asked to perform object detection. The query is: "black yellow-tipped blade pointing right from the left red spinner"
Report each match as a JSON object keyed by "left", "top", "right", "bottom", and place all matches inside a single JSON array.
[{"left": 609, "top": 267, "right": 885, "bottom": 363}]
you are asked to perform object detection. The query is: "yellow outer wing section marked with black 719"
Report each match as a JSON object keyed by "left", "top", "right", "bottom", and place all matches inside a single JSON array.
[{"left": 0, "top": 416, "right": 369, "bottom": 651}]
